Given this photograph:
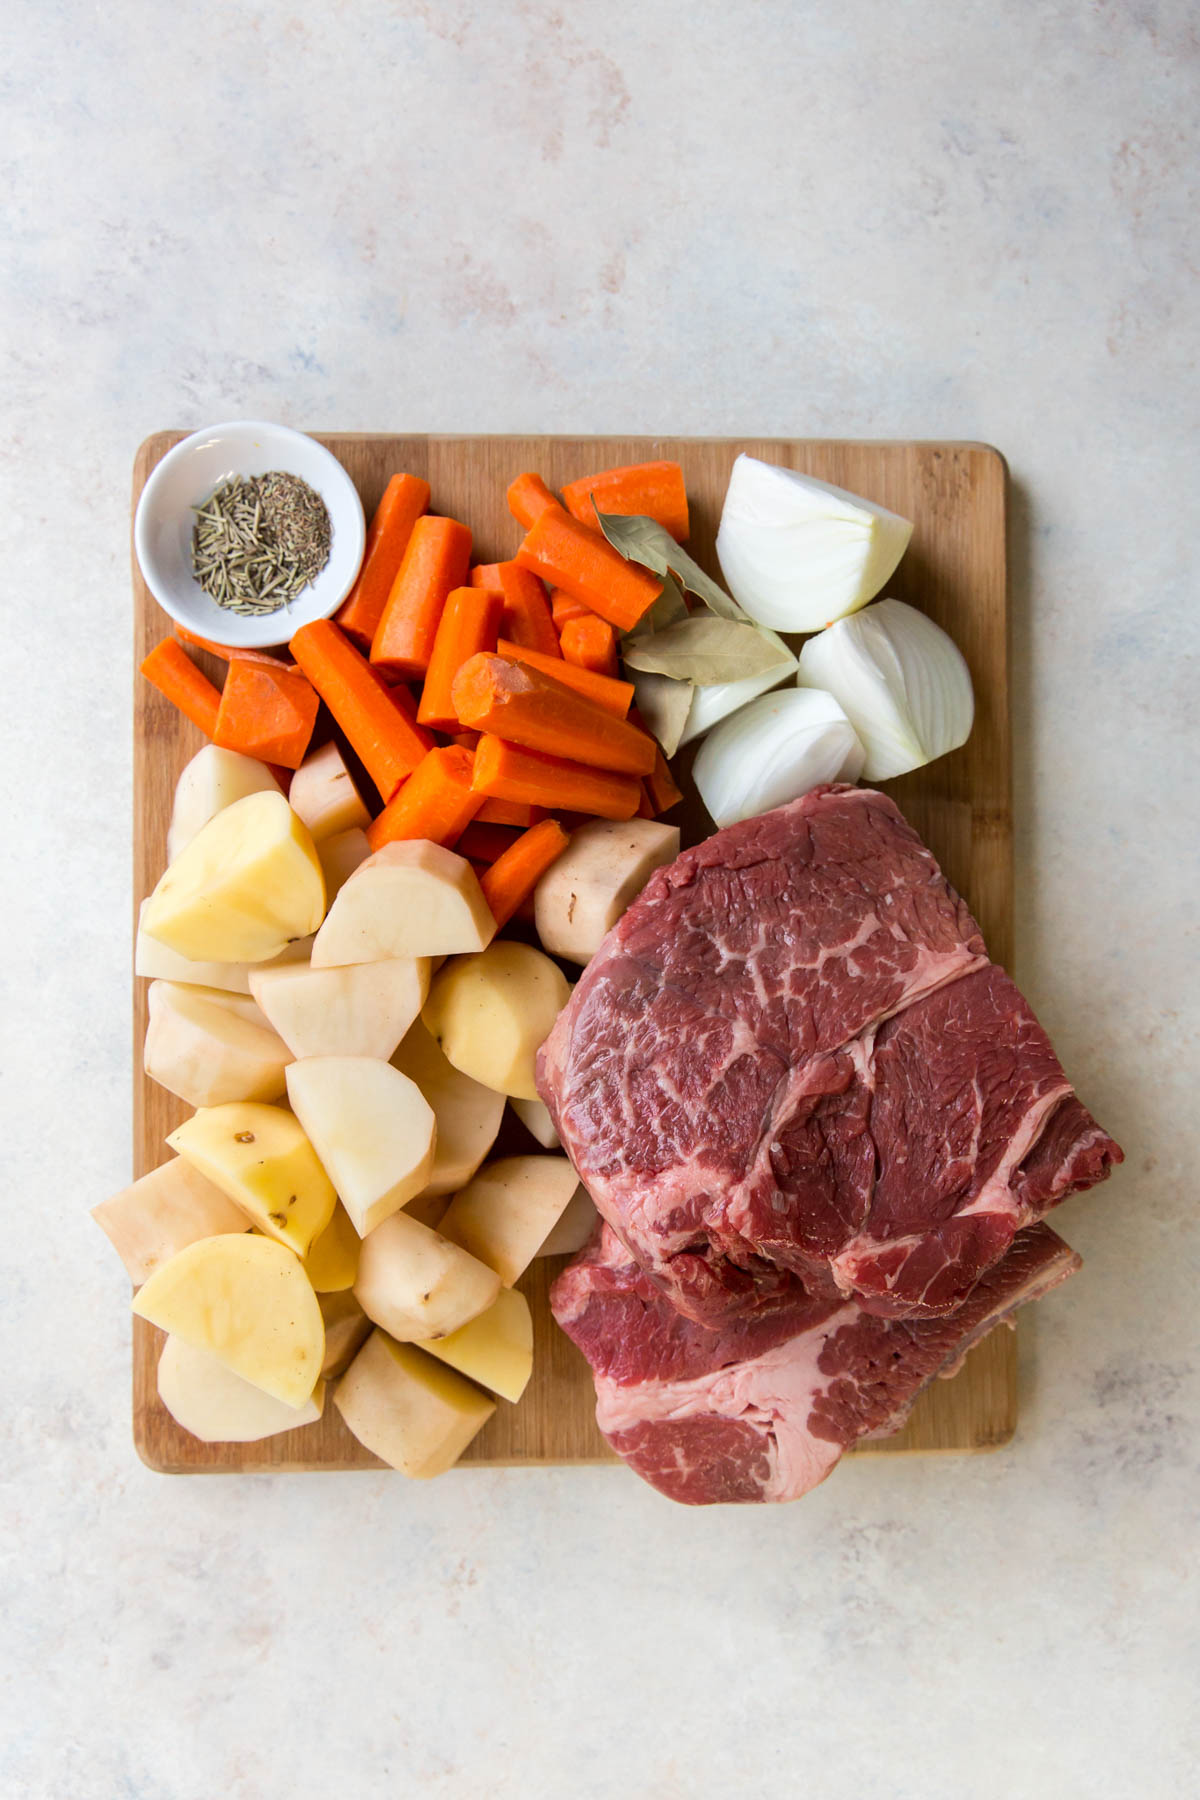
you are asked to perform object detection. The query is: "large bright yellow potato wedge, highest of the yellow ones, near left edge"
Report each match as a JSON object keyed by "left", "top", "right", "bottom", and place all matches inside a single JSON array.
[{"left": 142, "top": 790, "right": 326, "bottom": 963}]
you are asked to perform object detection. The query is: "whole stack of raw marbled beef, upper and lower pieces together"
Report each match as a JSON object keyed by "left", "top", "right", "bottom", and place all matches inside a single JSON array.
[{"left": 538, "top": 787, "right": 1121, "bottom": 1505}]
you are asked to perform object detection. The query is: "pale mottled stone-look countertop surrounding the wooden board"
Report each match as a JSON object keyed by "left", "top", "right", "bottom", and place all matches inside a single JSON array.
[{"left": 0, "top": 0, "right": 1200, "bottom": 1800}]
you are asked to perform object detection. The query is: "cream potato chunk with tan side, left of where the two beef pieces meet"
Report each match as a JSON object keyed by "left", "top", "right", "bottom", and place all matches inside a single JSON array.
[{"left": 439, "top": 1156, "right": 579, "bottom": 1287}]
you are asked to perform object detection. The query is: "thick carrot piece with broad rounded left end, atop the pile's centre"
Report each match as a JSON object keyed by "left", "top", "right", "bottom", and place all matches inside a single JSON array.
[{"left": 452, "top": 653, "right": 655, "bottom": 776}]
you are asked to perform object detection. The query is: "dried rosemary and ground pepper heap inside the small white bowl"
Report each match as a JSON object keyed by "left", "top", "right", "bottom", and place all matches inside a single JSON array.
[{"left": 193, "top": 468, "right": 331, "bottom": 617}]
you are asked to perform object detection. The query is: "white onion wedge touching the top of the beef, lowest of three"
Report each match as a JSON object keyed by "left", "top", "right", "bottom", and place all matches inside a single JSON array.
[{"left": 693, "top": 688, "right": 862, "bottom": 826}]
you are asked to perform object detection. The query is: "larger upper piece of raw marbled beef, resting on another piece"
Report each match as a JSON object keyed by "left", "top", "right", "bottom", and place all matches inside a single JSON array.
[{"left": 540, "top": 787, "right": 1121, "bottom": 1327}]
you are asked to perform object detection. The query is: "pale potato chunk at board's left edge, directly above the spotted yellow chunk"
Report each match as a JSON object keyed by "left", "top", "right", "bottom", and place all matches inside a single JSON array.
[{"left": 144, "top": 981, "right": 291, "bottom": 1107}]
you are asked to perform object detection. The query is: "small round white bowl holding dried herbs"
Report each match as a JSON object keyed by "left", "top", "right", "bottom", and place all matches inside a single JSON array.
[{"left": 133, "top": 419, "right": 367, "bottom": 650}]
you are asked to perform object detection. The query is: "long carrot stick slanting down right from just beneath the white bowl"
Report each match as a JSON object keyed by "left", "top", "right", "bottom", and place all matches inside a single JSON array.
[{"left": 291, "top": 619, "right": 434, "bottom": 801}]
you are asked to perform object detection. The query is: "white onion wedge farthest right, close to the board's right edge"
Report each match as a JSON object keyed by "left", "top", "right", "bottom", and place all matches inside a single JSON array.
[{"left": 797, "top": 599, "right": 975, "bottom": 781}]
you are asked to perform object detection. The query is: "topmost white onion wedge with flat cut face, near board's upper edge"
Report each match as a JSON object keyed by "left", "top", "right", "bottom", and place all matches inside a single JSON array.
[{"left": 716, "top": 455, "right": 912, "bottom": 632}]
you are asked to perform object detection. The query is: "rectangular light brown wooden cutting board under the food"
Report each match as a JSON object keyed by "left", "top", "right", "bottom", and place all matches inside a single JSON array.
[{"left": 133, "top": 432, "right": 1016, "bottom": 1474}]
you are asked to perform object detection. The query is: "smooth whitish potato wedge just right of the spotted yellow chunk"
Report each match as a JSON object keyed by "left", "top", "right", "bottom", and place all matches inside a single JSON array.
[{"left": 288, "top": 1057, "right": 435, "bottom": 1237}]
